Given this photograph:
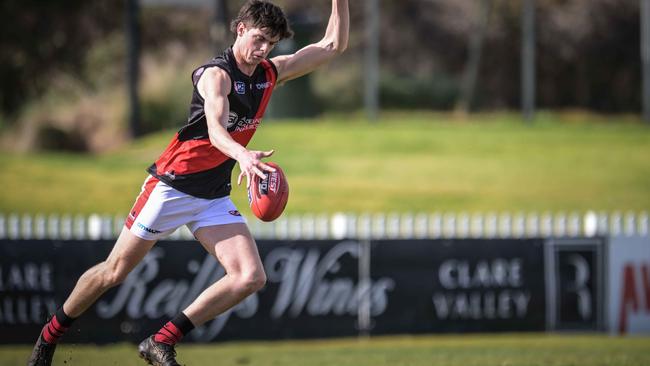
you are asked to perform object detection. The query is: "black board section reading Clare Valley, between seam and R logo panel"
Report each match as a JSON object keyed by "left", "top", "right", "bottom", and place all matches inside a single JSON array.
[{"left": 371, "top": 239, "right": 545, "bottom": 334}]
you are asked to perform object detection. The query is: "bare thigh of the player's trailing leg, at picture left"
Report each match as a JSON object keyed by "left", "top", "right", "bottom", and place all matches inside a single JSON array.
[{"left": 106, "top": 227, "right": 156, "bottom": 273}]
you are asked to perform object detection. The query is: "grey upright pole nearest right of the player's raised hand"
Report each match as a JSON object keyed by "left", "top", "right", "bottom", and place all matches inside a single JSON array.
[{"left": 364, "top": 0, "right": 380, "bottom": 122}]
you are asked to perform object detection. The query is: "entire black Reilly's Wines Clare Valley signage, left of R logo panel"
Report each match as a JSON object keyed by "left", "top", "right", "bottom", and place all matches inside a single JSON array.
[{"left": 0, "top": 239, "right": 546, "bottom": 343}]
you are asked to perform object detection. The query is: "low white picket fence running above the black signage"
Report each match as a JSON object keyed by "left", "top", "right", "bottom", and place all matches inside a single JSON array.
[{"left": 0, "top": 211, "right": 649, "bottom": 240}]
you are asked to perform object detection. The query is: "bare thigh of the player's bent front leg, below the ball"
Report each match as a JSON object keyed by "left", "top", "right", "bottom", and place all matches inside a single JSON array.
[{"left": 194, "top": 223, "right": 263, "bottom": 273}]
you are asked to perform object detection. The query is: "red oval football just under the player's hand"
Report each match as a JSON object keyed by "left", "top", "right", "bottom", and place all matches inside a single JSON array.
[{"left": 248, "top": 162, "right": 289, "bottom": 221}]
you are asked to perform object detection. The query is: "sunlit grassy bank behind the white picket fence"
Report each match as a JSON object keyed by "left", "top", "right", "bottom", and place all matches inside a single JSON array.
[{"left": 0, "top": 113, "right": 650, "bottom": 213}]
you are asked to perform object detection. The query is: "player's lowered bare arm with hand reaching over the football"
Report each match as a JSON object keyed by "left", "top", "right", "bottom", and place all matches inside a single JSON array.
[{"left": 197, "top": 67, "right": 275, "bottom": 186}]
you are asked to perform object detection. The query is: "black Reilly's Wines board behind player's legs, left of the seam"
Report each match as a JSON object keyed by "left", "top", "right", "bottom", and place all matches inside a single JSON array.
[{"left": 0, "top": 240, "right": 359, "bottom": 343}]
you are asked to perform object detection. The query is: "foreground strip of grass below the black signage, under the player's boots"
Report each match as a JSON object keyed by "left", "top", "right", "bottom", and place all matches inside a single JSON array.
[{"left": 0, "top": 334, "right": 650, "bottom": 366}]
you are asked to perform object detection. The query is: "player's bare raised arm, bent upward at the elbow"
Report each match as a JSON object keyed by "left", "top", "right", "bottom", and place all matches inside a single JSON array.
[{"left": 271, "top": 0, "right": 350, "bottom": 84}]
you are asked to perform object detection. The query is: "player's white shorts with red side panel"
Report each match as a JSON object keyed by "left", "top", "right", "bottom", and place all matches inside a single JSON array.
[{"left": 125, "top": 176, "right": 246, "bottom": 240}]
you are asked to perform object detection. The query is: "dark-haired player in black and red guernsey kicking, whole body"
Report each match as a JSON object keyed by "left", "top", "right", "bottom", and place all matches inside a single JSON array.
[{"left": 28, "top": 0, "right": 349, "bottom": 366}]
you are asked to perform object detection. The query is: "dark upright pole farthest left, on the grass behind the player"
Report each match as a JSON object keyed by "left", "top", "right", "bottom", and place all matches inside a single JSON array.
[{"left": 126, "top": 0, "right": 141, "bottom": 137}]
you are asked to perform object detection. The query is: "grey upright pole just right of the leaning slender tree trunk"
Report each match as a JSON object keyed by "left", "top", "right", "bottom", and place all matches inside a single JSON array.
[{"left": 521, "top": 0, "right": 535, "bottom": 123}]
